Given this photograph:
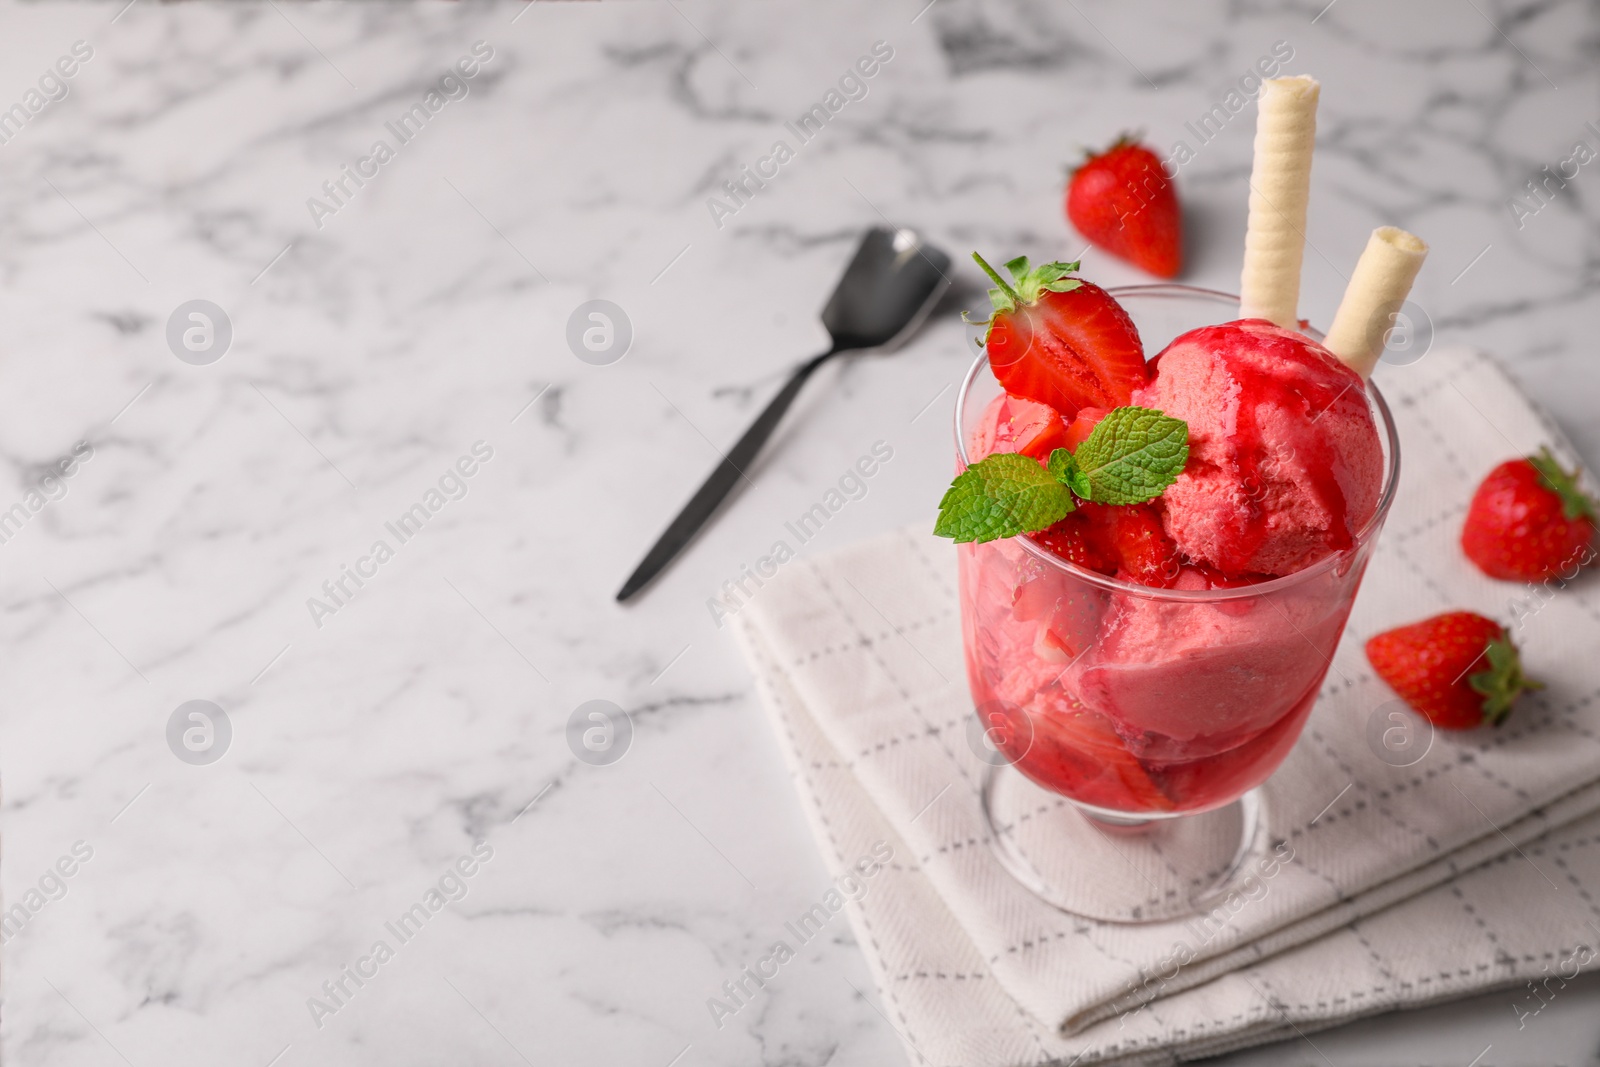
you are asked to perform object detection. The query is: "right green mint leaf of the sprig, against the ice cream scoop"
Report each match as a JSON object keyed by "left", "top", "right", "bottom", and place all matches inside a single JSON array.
[{"left": 1070, "top": 406, "right": 1189, "bottom": 504}]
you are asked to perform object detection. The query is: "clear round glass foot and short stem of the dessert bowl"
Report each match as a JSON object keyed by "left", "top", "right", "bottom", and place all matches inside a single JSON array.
[{"left": 982, "top": 763, "right": 1269, "bottom": 923}]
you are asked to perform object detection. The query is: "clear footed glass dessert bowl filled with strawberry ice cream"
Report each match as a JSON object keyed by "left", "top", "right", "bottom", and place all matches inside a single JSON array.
[{"left": 955, "top": 285, "right": 1398, "bottom": 921}]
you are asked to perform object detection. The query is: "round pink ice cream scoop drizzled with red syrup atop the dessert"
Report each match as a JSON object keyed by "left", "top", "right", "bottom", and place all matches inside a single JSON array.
[{"left": 1134, "top": 318, "right": 1384, "bottom": 574}]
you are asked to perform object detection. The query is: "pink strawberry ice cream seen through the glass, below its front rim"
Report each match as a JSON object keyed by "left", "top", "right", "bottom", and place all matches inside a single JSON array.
[{"left": 960, "top": 541, "right": 1366, "bottom": 813}]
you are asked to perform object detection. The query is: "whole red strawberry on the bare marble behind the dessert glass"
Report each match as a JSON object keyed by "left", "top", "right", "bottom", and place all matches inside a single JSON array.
[{"left": 1067, "top": 136, "right": 1184, "bottom": 278}]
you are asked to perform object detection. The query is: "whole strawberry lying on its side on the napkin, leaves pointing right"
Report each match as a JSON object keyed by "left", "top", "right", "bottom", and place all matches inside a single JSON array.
[{"left": 1366, "top": 611, "right": 1542, "bottom": 729}]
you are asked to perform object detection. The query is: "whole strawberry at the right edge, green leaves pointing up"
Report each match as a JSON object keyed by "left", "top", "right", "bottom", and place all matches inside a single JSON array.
[{"left": 1461, "top": 448, "right": 1600, "bottom": 582}]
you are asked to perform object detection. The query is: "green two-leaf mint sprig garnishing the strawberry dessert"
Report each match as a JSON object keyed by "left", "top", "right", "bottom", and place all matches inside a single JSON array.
[{"left": 933, "top": 406, "right": 1189, "bottom": 542}]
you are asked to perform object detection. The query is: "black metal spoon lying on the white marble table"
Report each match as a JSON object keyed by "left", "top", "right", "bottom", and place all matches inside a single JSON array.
[{"left": 616, "top": 227, "right": 950, "bottom": 600}]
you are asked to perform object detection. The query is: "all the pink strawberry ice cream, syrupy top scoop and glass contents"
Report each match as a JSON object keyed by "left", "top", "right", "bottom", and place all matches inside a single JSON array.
[{"left": 960, "top": 313, "right": 1387, "bottom": 814}]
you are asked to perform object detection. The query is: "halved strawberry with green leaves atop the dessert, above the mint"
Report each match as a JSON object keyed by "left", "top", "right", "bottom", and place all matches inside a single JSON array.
[{"left": 973, "top": 253, "right": 1149, "bottom": 419}]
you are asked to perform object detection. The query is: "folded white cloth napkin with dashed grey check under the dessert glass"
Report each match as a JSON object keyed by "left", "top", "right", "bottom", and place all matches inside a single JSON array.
[{"left": 734, "top": 349, "right": 1600, "bottom": 1067}]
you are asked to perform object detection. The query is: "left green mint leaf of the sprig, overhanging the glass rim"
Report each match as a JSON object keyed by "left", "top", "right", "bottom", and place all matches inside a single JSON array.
[{"left": 933, "top": 453, "right": 1077, "bottom": 542}]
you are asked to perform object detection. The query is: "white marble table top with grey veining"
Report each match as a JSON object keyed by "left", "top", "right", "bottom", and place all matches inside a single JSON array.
[{"left": 0, "top": 0, "right": 1600, "bottom": 1067}]
